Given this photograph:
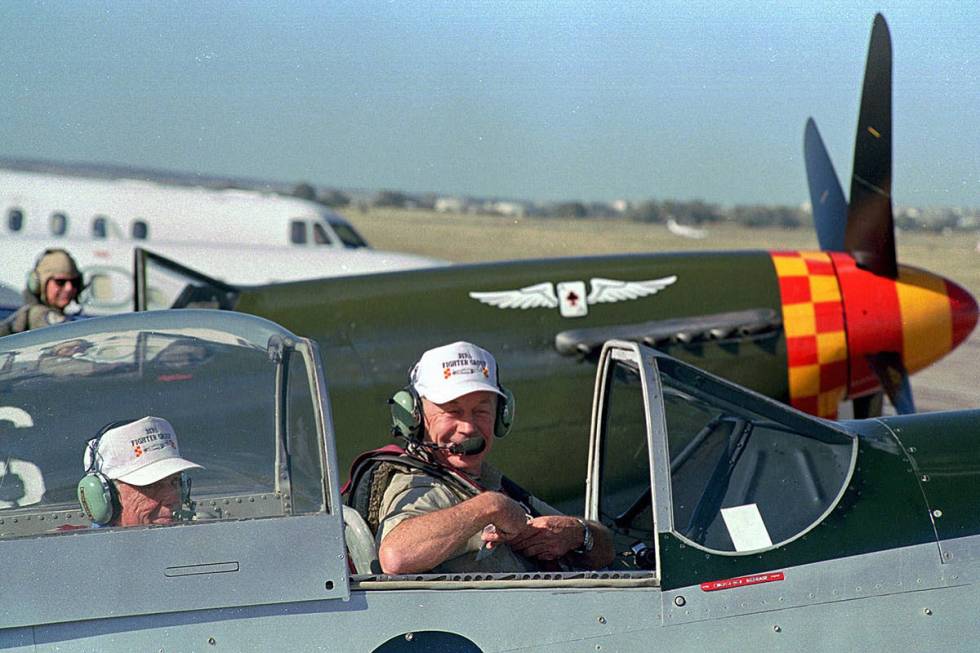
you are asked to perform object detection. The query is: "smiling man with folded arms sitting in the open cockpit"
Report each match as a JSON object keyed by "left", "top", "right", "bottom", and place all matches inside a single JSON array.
[{"left": 377, "top": 342, "right": 614, "bottom": 574}]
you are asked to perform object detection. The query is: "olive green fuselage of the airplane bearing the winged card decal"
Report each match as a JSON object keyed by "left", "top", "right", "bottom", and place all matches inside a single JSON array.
[{"left": 236, "top": 252, "right": 788, "bottom": 501}]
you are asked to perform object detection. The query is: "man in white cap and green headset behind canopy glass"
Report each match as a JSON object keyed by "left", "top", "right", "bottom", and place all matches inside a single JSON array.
[{"left": 78, "top": 417, "right": 203, "bottom": 526}]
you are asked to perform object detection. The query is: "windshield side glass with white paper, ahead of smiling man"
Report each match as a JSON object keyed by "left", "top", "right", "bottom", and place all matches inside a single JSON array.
[{"left": 658, "top": 361, "right": 854, "bottom": 552}]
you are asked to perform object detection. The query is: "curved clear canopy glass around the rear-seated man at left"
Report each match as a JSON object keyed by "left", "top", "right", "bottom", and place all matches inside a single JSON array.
[{"left": 0, "top": 329, "right": 290, "bottom": 538}]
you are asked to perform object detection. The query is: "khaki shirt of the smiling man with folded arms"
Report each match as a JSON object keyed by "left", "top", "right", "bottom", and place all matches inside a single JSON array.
[{"left": 376, "top": 463, "right": 557, "bottom": 574}]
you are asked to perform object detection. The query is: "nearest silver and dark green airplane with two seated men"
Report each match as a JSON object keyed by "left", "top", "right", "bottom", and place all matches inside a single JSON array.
[{"left": 0, "top": 310, "right": 980, "bottom": 653}]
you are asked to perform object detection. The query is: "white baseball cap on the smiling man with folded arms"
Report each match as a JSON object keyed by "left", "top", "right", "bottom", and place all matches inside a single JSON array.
[{"left": 411, "top": 342, "right": 504, "bottom": 404}]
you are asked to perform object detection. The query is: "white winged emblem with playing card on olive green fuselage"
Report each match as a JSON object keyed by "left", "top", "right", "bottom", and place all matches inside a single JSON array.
[{"left": 470, "top": 275, "right": 677, "bottom": 317}]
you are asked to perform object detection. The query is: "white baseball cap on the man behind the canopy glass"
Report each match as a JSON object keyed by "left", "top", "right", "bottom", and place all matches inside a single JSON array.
[{"left": 84, "top": 417, "right": 204, "bottom": 486}]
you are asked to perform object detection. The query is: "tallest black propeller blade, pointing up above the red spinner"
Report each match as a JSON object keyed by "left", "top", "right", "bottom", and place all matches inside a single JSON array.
[{"left": 844, "top": 14, "right": 898, "bottom": 279}]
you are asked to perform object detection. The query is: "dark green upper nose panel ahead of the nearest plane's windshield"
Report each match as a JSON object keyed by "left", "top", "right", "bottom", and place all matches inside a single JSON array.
[{"left": 660, "top": 410, "right": 980, "bottom": 589}]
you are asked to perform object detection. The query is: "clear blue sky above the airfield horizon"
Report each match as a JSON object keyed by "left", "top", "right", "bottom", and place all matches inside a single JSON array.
[{"left": 0, "top": 0, "right": 980, "bottom": 207}]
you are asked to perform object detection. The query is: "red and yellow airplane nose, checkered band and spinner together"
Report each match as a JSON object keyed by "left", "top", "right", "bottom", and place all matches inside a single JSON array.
[{"left": 771, "top": 252, "right": 977, "bottom": 418}]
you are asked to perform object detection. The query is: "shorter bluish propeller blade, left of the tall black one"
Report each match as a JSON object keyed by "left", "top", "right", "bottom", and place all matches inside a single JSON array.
[{"left": 803, "top": 118, "right": 847, "bottom": 252}]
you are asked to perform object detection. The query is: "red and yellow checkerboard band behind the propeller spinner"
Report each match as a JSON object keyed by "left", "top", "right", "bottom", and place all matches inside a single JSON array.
[{"left": 770, "top": 252, "right": 847, "bottom": 419}]
